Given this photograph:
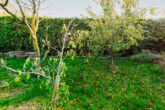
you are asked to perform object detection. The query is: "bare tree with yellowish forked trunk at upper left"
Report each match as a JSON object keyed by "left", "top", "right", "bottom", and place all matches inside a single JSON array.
[{"left": 0, "top": 0, "right": 45, "bottom": 65}]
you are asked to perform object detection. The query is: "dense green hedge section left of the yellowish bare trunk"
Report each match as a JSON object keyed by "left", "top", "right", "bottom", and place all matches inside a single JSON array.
[{"left": 0, "top": 17, "right": 29, "bottom": 52}]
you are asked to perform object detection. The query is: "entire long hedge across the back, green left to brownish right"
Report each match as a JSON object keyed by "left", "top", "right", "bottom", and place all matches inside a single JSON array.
[{"left": 0, "top": 17, "right": 165, "bottom": 55}]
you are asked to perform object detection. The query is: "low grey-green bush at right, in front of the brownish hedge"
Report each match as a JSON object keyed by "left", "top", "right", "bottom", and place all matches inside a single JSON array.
[{"left": 130, "top": 50, "right": 162, "bottom": 63}]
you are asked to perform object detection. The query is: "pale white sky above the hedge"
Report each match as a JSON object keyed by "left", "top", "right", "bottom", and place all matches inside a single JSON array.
[{"left": 40, "top": 0, "right": 165, "bottom": 18}]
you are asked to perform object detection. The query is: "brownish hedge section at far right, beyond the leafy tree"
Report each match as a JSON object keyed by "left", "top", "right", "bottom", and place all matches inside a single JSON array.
[{"left": 140, "top": 19, "right": 165, "bottom": 52}]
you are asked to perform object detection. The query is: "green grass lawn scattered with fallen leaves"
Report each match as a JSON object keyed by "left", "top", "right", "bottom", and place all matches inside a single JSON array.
[{"left": 0, "top": 57, "right": 165, "bottom": 110}]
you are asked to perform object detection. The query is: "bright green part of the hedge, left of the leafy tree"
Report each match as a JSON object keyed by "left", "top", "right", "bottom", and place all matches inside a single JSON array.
[{"left": 0, "top": 17, "right": 90, "bottom": 54}]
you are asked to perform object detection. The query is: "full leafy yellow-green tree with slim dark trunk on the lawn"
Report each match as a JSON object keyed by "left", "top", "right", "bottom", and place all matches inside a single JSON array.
[{"left": 88, "top": 0, "right": 144, "bottom": 69}]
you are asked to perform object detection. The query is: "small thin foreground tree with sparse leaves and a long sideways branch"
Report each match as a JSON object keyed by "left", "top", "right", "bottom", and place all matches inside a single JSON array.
[{"left": 0, "top": 20, "right": 74, "bottom": 110}]
